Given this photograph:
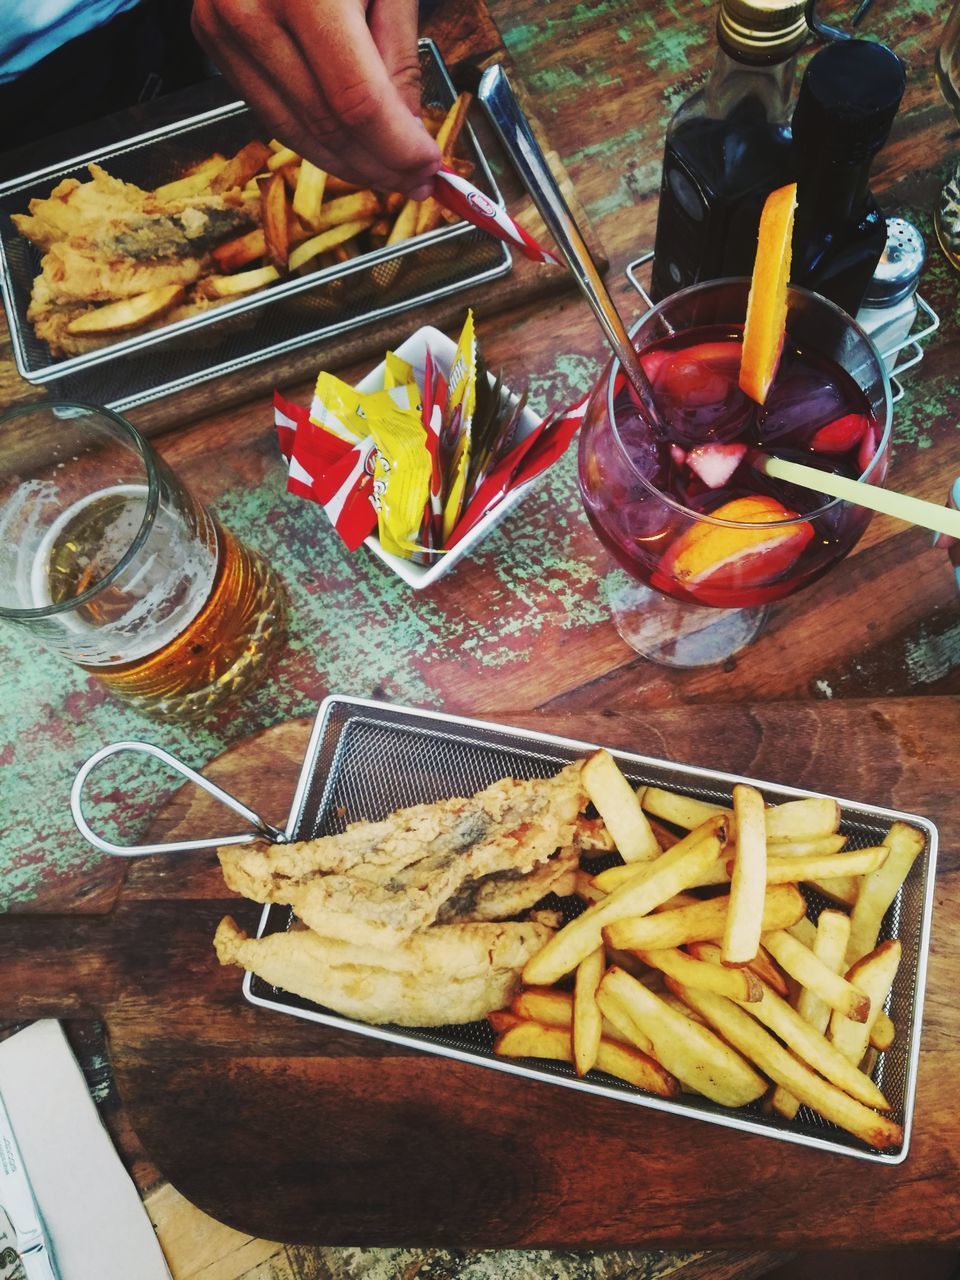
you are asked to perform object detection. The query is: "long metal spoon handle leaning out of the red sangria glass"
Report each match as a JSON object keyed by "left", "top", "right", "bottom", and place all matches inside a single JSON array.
[{"left": 477, "top": 63, "right": 659, "bottom": 424}]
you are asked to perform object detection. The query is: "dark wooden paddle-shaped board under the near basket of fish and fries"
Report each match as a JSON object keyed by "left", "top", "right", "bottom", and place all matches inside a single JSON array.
[{"left": 0, "top": 698, "right": 960, "bottom": 1249}]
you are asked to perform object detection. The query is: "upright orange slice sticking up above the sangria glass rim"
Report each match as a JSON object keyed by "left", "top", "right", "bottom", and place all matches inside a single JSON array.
[{"left": 740, "top": 182, "right": 796, "bottom": 404}]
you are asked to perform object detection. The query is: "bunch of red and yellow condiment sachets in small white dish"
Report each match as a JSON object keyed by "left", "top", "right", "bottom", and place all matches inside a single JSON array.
[{"left": 274, "top": 312, "right": 585, "bottom": 564}]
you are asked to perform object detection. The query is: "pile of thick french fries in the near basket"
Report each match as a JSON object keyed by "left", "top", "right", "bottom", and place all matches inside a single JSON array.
[{"left": 489, "top": 750, "right": 924, "bottom": 1149}]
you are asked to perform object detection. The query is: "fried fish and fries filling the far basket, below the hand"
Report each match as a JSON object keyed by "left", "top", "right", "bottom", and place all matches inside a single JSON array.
[{"left": 13, "top": 95, "right": 474, "bottom": 357}]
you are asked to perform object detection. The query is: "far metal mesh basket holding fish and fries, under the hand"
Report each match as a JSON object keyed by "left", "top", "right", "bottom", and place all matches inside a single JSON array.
[{"left": 0, "top": 40, "right": 512, "bottom": 410}]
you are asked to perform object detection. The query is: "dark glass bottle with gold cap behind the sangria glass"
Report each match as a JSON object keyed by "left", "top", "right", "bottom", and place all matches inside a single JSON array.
[{"left": 650, "top": 0, "right": 808, "bottom": 301}]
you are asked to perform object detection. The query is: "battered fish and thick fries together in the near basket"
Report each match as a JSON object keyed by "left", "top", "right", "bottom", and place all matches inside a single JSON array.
[{"left": 216, "top": 750, "right": 924, "bottom": 1151}]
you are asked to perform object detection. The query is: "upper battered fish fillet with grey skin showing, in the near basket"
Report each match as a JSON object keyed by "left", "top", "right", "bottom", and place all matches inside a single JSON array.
[{"left": 219, "top": 762, "right": 588, "bottom": 947}]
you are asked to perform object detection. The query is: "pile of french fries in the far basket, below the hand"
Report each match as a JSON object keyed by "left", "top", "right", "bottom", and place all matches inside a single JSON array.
[{"left": 163, "top": 93, "right": 474, "bottom": 300}]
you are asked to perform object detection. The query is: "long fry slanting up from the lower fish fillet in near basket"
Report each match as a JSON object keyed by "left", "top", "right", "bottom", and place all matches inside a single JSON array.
[{"left": 524, "top": 835, "right": 727, "bottom": 987}]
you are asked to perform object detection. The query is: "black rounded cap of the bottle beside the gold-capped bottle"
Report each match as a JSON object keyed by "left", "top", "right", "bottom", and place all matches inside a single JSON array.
[{"left": 794, "top": 40, "right": 906, "bottom": 164}]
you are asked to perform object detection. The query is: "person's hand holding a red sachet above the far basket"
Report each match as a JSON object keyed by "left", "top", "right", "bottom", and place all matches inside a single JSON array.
[{"left": 193, "top": 0, "right": 440, "bottom": 200}]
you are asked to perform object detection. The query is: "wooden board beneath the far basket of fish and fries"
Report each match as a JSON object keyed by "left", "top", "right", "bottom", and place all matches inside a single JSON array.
[{"left": 0, "top": 0, "right": 607, "bottom": 436}]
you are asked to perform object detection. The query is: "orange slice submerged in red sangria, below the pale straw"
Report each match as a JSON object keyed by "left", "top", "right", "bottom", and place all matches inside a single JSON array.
[{"left": 652, "top": 494, "right": 814, "bottom": 604}]
